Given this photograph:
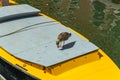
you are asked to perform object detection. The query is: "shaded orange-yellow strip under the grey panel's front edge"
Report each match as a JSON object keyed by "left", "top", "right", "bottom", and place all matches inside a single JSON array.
[{"left": 51, "top": 51, "right": 100, "bottom": 75}]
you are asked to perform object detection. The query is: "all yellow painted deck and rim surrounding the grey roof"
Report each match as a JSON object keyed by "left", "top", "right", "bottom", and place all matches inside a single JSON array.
[{"left": 0, "top": 0, "right": 120, "bottom": 80}]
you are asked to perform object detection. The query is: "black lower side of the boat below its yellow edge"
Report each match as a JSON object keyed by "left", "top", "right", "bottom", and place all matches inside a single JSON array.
[{"left": 0, "top": 58, "right": 40, "bottom": 80}]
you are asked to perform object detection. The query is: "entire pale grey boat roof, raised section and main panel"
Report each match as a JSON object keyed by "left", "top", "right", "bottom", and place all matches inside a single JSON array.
[{"left": 0, "top": 5, "right": 98, "bottom": 67}]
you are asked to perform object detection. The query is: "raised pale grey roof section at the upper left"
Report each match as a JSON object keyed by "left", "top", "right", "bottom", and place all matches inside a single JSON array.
[{"left": 0, "top": 4, "right": 40, "bottom": 22}]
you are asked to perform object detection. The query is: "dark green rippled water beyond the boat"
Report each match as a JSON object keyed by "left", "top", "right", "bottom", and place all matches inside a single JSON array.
[{"left": 16, "top": 0, "right": 120, "bottom": 67}]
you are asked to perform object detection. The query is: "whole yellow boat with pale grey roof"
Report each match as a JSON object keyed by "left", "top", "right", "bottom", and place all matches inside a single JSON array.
[{"left": 0, "top": 1, "right": 120, "bottom": 80}]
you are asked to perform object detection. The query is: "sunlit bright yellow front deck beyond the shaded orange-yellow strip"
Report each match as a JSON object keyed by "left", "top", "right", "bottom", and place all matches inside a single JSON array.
[{"left": 53, "top": 50, "right": 120, "bottom": 80}]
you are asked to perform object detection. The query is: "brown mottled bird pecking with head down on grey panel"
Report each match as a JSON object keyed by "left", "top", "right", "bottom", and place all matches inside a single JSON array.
[{"left": 56, "top": 32, "right": 71, "bottom": 48}]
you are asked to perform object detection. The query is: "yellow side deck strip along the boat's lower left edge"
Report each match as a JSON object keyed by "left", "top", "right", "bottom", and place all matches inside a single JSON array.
[{"left": 0, "top": 47, "right": 53, "bottom": 80}]
